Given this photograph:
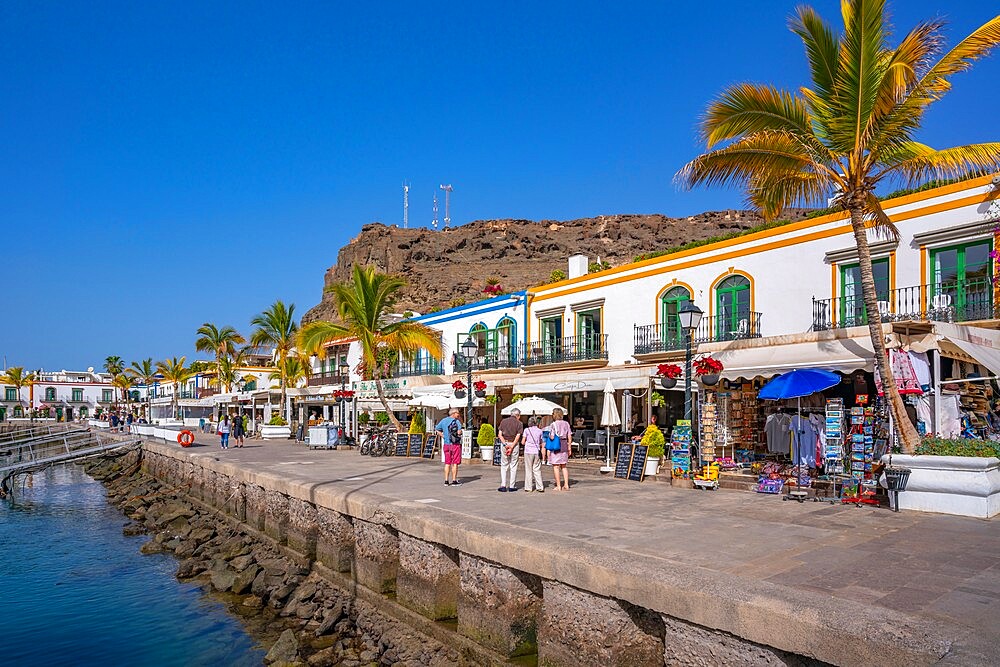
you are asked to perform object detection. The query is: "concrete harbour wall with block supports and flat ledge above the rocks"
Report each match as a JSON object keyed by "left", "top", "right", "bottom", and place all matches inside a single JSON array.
[{"left": 143, "top": 443, "right": 950, "bottom": 666}]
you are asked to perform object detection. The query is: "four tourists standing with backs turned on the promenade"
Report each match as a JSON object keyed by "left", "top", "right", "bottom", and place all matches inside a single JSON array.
[{"left": 434, "top": 408, "right": 573, "bottom": 493}]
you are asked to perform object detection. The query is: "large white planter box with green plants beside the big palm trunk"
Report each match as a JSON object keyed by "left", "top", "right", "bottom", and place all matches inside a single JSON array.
[{"left": 882, "top": 454, "right": 1000, "bottom": 519}]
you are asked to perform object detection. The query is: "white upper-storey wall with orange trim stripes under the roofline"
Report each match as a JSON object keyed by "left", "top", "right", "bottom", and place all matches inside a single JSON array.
[{"left": 528, "top": 179, "right": 990, "bottom": 365}]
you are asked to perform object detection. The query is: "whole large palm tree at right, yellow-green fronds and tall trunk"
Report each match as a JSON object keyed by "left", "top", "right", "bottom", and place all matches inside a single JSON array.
[{"left": 678, "top": 0, "right": 1000, "bottom": 453}]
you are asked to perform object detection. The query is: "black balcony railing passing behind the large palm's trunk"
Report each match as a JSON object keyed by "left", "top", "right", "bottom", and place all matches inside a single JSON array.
[{"left": 813, "top": 278, "right": 996, "bottom": 331}]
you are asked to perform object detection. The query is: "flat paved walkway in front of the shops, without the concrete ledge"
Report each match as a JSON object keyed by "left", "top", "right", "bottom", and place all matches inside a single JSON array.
[{"left": 176, "top": 436, "right": 1000, "bottom": 656}]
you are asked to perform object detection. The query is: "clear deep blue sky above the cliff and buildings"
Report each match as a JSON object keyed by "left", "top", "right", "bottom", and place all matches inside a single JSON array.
[{"left": 0, "top": 0, "right": 1000, "bottom": 368}]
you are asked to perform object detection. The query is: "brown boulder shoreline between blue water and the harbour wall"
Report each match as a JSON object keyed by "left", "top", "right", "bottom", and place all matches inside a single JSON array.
[{"left": 85, "top": 450, "right": 468, "bottom": 667}]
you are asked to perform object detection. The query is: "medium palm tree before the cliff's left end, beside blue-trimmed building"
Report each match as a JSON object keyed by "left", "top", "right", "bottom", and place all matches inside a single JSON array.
[{"left": 299, "top": 266, "right": 442, "bottom": 432}]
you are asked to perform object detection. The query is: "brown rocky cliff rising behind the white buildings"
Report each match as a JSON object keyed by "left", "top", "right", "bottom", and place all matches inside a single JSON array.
[{"left": 303, "top": 209, "right": 808, "bottom": 322}]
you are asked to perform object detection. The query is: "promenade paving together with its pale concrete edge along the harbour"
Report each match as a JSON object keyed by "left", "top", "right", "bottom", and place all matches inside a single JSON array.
[{"left": 160, "top": 436, "right": 1000, "bottom": 664}]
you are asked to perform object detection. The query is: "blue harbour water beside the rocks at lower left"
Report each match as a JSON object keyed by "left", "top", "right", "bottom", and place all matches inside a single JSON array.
[{"left": 0, "top": 466, "right": 264, "bottom": 667}]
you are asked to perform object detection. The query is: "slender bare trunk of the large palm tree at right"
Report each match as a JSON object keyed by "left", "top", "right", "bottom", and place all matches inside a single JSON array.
[{"left": 850, "top": 206, "right": 920, "bottom": 454}]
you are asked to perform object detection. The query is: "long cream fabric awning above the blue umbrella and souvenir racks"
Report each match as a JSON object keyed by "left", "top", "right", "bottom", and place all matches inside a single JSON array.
[{"left": 712, "top": 337, "right": 875, "bottom": 380}]
